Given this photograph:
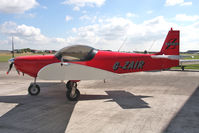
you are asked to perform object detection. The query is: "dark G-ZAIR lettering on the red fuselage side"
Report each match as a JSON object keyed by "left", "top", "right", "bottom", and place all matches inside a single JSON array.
[{"left": 113, "top": 60, "right": 145, "bottom": 71}]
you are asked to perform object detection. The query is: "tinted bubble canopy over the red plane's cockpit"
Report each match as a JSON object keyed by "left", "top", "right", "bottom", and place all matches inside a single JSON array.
[{"left": 55, "top": 45, "right": 98, "bottom": 62}]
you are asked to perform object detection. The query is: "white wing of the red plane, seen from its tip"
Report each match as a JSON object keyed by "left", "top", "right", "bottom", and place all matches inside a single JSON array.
[{"left": 38, "top": 63, "right": 118, "bottom": 80}]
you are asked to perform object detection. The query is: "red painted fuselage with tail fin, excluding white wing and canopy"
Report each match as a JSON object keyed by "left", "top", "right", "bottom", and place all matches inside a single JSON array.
[{"left": 14, "top": 29, "right": 179, "bottom": 77}]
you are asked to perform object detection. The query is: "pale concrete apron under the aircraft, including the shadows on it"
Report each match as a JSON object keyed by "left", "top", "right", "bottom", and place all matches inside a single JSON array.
[{"left": 0, "top": 63, "right": 199, "bottom": 133}]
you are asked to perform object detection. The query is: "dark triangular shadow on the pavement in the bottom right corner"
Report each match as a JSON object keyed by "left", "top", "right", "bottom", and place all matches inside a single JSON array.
[{"left": 163, "top": 86, "right": 199, "bottom": 133}]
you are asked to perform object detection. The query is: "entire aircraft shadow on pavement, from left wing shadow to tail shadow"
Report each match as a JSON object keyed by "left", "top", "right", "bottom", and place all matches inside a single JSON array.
[{"left": 0, "top": 83, "right": 149, "bottom": 133}]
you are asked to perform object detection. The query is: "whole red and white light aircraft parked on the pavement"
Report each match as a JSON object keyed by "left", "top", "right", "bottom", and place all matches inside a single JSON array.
[{"left": 7, "top": 28, "right": 180, "bottom": 101}]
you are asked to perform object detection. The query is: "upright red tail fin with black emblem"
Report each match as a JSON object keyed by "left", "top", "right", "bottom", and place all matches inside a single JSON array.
[{"left": 157, "top": 28, "right": 180, "bottom": 55}]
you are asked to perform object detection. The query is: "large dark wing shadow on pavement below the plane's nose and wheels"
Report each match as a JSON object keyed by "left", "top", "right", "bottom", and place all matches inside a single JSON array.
[{"left": 0, "top": 83, "right": 77, "bottom": 133}]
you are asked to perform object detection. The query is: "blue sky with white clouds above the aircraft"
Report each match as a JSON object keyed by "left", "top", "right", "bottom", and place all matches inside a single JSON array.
[{"left": 0, "top": 0, "right": 199, "bottom": 51}]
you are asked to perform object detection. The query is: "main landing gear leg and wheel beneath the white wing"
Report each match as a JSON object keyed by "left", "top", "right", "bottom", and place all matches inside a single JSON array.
[{"left": 66, "top": 81, "right": 80, "bottom": 101}]
